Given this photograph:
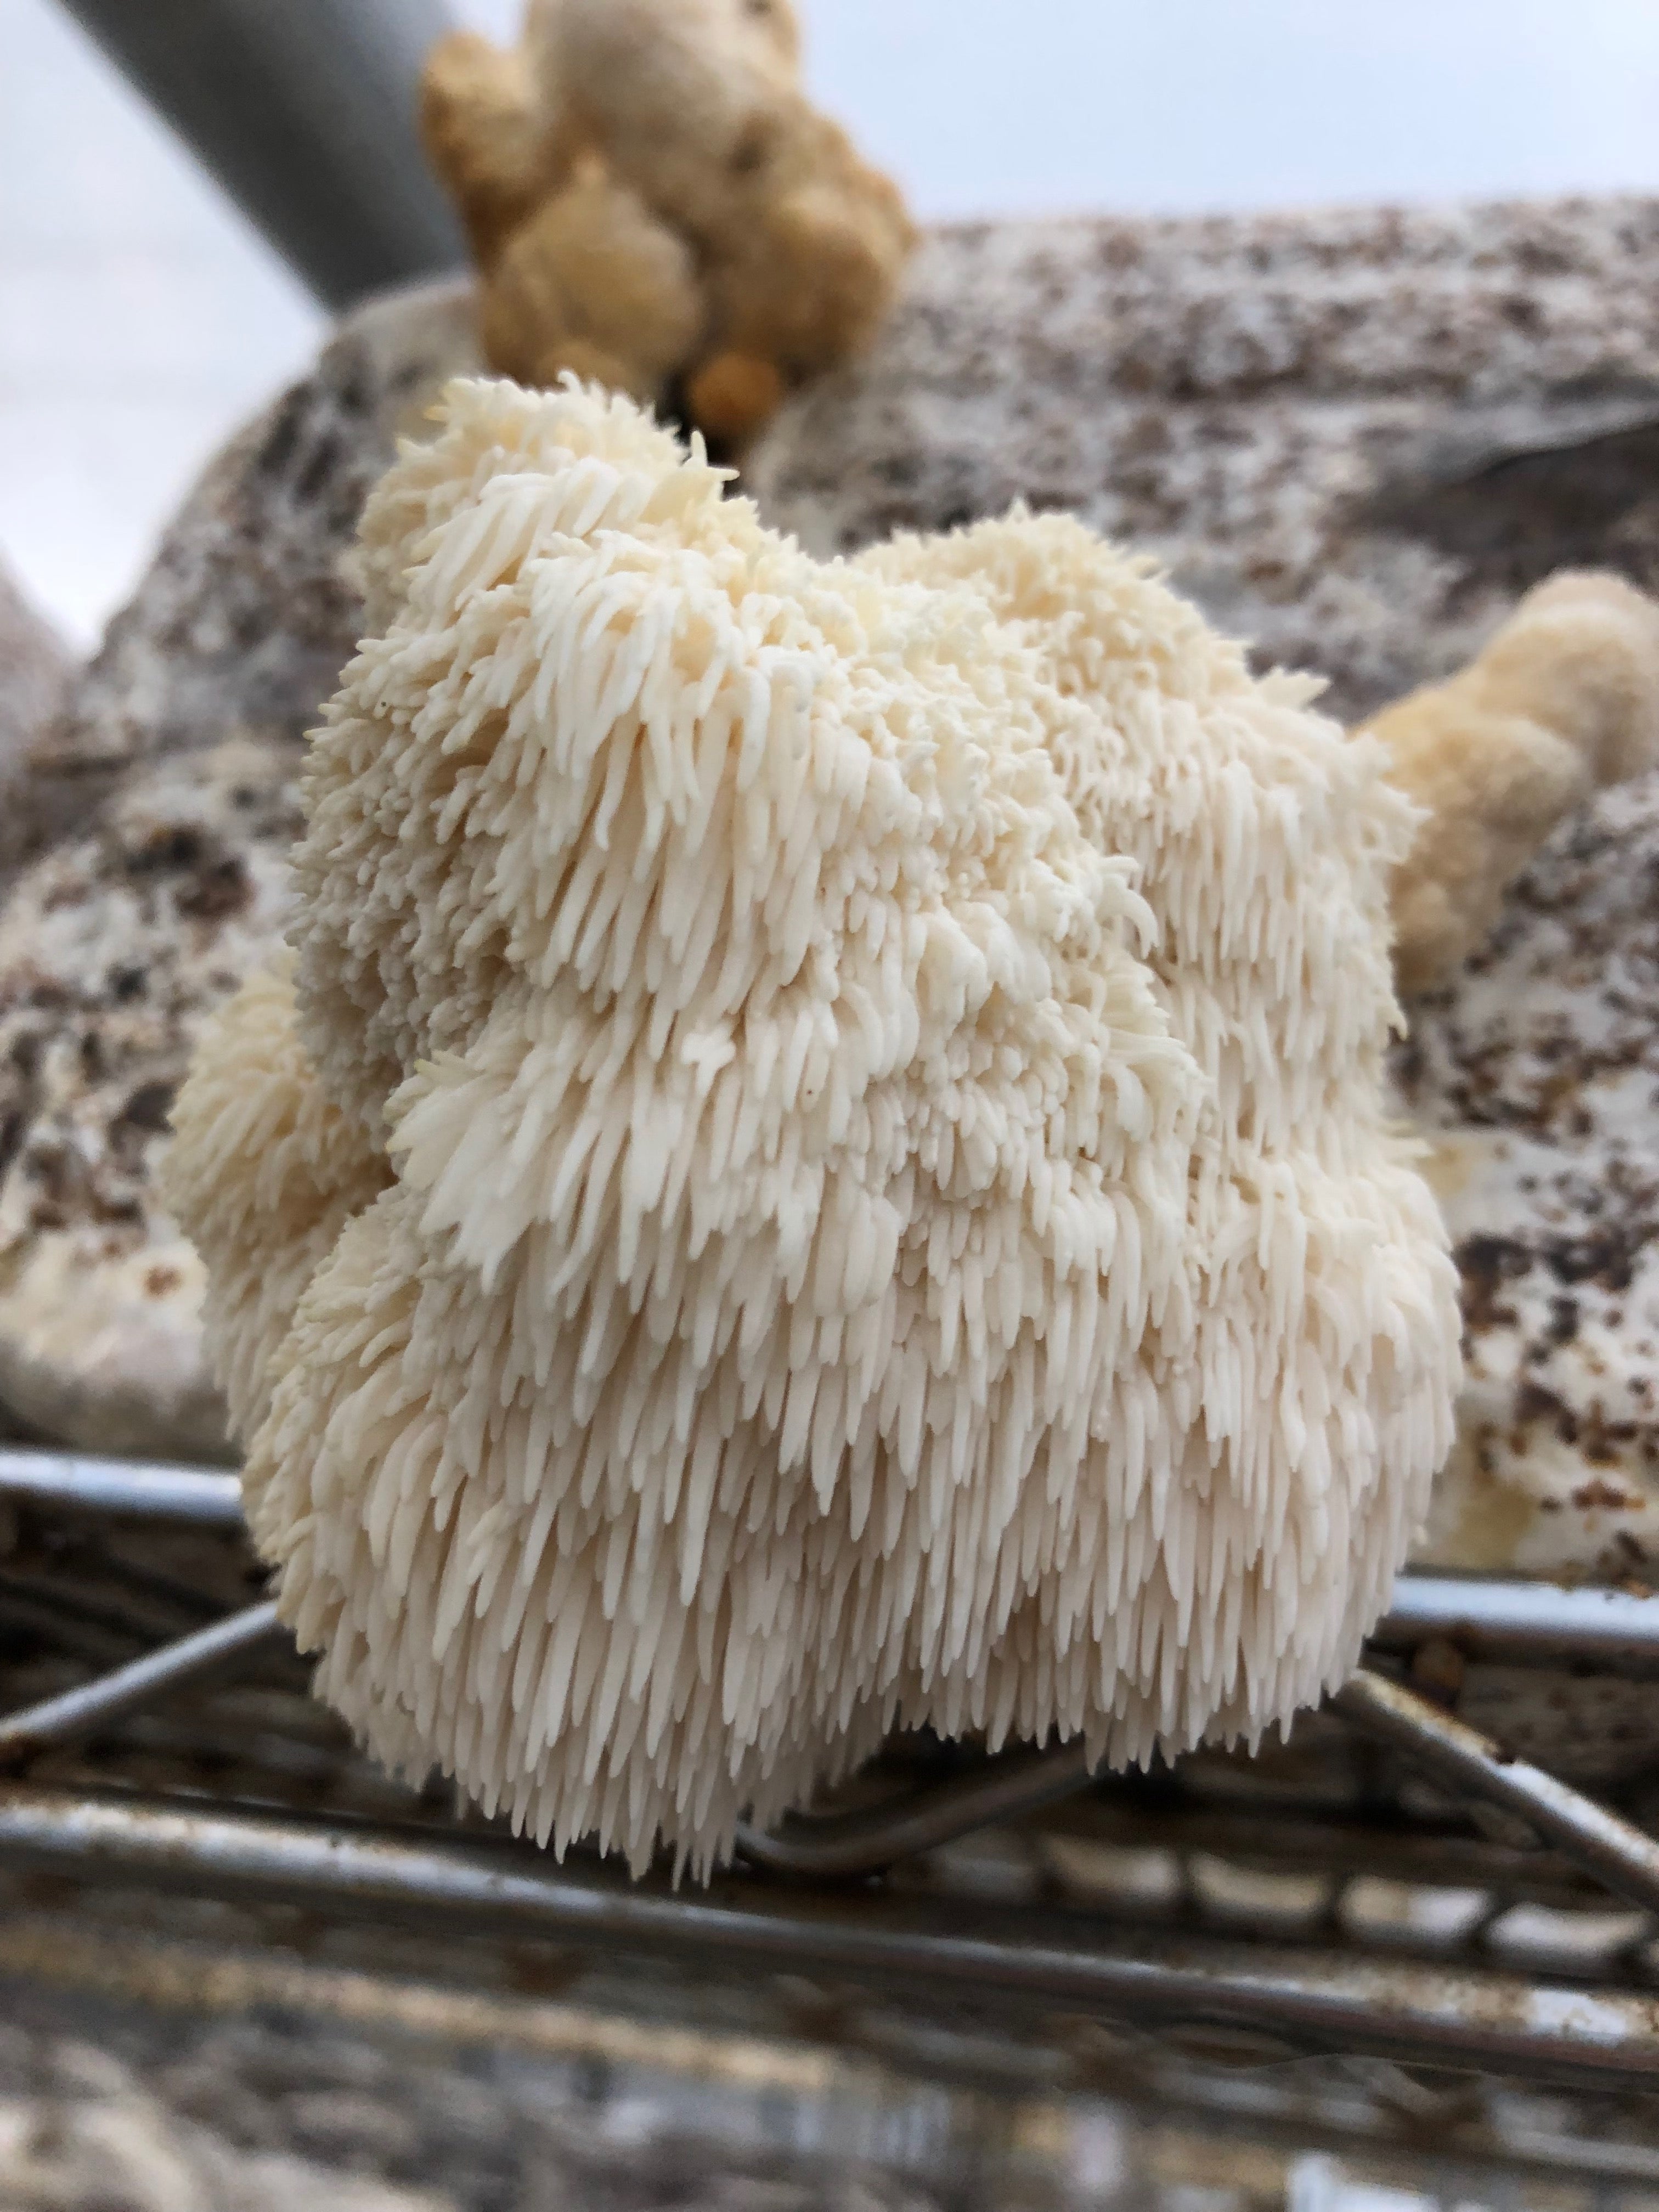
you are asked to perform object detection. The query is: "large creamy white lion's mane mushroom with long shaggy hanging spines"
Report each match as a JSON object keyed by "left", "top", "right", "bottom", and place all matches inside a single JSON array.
[{"left": 170, "top": 383, "right": 1458, "bottom": 1871}]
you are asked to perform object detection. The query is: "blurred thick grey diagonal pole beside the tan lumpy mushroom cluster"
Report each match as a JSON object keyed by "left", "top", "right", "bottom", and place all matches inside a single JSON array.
[{"left": 62, "top": 0, "right": 467, "bottom": 309}]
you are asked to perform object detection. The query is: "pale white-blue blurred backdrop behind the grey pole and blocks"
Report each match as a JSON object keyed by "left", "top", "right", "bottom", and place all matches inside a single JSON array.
[{"left": 0, "top": 0, "right": 1659, "bottom": 644}]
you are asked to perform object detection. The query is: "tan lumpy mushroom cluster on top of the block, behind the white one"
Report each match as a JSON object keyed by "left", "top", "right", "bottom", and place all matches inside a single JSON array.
[{"left": 420, "top": 0, "right": 916, "bottom": 452}]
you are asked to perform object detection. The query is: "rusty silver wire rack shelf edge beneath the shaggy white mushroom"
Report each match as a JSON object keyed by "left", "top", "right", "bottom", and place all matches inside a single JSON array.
[{"left": 0, "top": 1449, "right": 1659, "bottom": 2183}]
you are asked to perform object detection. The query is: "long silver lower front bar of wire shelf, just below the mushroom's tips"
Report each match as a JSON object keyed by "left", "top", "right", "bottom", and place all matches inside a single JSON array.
[{"left": 0, "top": 1783, "right": 1659, "bottom": 2090}]
